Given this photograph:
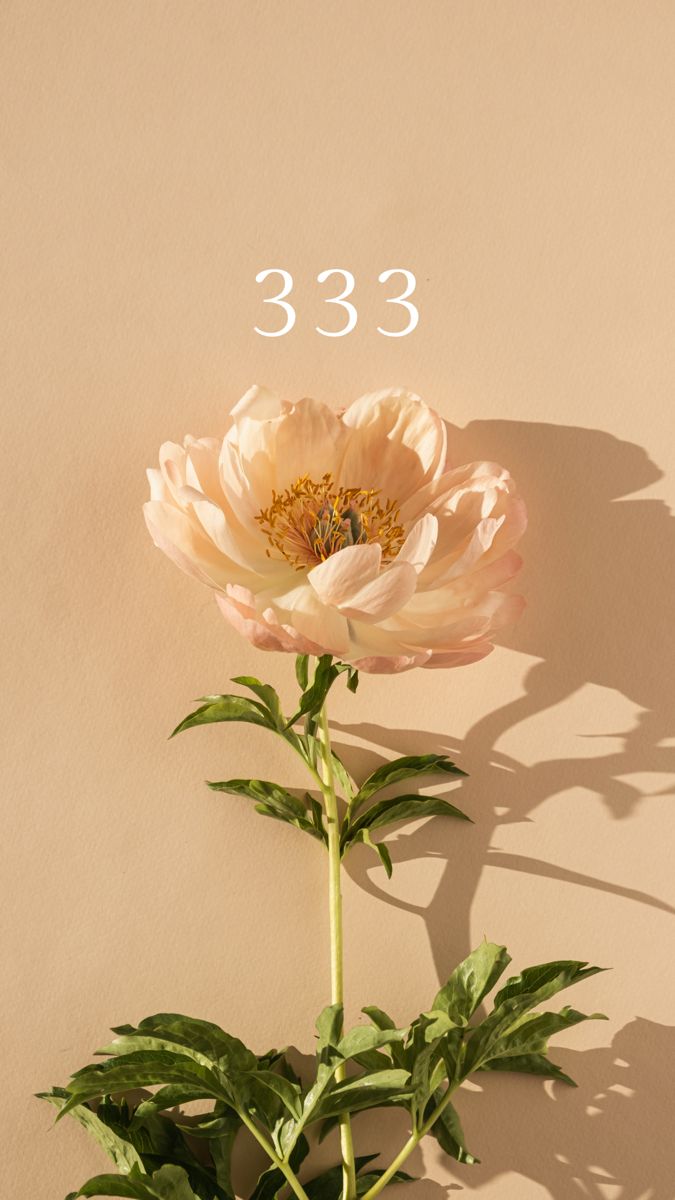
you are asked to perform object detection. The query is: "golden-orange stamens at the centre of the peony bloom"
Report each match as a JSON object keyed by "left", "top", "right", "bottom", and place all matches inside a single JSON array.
[{"left": 256, "top": 474, "right": 406, "bottom": 570}]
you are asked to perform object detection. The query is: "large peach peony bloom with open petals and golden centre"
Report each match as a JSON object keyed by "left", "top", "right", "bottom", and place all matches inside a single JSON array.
[{"left": 144, "top": 388, "right": 526, "bottom": 672}]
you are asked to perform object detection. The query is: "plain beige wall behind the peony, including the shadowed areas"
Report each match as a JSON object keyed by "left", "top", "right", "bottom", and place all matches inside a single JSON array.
[{"left": 0, "top": 0, "right": 675, "bottom": 1200}]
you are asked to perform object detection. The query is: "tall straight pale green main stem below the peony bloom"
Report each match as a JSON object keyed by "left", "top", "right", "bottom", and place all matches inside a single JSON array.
[{"left": 318, "top": 703, "right": 357, "bottom": 1200}]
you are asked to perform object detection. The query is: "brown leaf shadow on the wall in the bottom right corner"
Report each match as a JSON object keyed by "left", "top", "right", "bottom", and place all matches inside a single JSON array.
[{"left": 441, "top": 1018, "right": 675, "bottom": 1200}]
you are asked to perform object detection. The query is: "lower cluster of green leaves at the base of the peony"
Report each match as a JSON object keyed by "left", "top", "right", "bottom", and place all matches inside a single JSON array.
[{"left": 41, "top": 942, "right": 601, "bottom": 1200}]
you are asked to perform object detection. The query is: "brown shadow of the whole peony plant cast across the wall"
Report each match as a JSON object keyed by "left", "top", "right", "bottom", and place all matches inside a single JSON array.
[{"left": 334, "top": 421, "right": 675, "bottom": 1200}]
